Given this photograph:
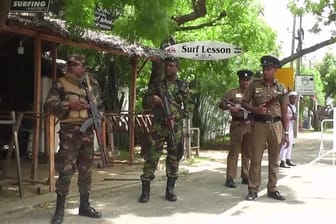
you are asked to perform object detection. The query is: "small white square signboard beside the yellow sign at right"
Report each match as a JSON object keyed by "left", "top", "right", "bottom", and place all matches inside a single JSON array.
[{"left": 295, "top": 75, "right": 315, "bottom": 96}]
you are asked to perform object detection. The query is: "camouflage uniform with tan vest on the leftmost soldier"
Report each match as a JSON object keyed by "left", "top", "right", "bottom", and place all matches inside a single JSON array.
[{"left": 44, "top": 73, "right": 101, "bottom": 195}]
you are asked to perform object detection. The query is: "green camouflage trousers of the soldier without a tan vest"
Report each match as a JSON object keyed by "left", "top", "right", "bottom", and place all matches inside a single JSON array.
[{"left": 140, "top": 128, "right": 184, "bottom": 181}]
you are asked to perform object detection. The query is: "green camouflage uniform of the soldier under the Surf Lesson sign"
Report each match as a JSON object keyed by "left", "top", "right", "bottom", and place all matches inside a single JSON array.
[{"left": 141, "top": 80, "right": 192, "bottom": 181}]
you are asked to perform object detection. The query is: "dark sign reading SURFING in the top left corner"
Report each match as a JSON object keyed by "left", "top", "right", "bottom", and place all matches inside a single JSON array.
[{"left": 9, "top": 0, "right": 50, "bottom": 12}]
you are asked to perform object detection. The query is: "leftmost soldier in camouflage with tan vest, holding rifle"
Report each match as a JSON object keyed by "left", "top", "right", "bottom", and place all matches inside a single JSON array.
[{"left": 44, "top": 55, "right": 102, "bottom": 224}]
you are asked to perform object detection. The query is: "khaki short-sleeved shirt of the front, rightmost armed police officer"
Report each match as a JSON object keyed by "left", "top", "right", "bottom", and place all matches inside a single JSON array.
[{"left": 243, "top": 79, "right": 288, "bottom": 117}]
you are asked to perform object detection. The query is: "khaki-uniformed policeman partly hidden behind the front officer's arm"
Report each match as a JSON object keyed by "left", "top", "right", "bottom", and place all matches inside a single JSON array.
[{"left": 219, "top": 70, "right": 253, "bottom": 188}]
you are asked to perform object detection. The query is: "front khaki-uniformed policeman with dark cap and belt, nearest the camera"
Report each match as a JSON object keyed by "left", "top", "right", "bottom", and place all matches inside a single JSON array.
[{"left": 242, "top": 55, "right": 288, "bottom": 201}]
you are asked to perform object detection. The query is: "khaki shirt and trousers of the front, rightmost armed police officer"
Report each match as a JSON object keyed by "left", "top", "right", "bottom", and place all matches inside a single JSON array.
[{"left": 243, "top": 79, "right": 287, "bottom": 192}]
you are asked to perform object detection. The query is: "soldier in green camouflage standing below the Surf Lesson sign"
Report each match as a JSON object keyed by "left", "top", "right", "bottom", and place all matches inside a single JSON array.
[{"left": 139, "top": 57, "right": 192, "bottom": 202}]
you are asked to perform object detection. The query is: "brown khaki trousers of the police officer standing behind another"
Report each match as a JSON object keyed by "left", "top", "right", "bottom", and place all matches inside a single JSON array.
[{"left": 226, "top": 121, "right": 251, "bottom": 179}]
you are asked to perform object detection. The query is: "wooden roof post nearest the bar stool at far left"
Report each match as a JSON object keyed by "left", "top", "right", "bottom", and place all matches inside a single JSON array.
[{"left": 31, "top": 35, "right": 42, "bottom": 180}]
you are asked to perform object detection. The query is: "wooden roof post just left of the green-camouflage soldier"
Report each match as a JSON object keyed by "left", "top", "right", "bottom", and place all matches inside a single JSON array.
[{"left": 128, "top": 56, "right": 138, "bottom": 162}]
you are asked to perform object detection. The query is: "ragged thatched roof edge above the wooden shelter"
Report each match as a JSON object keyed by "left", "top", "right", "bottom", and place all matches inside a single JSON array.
[{"left": 6, "top": 14, "right": 165, "bottom": 58}]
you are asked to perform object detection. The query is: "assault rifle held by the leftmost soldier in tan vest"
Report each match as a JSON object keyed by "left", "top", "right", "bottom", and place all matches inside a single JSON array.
[{"left": 79, "top": 78, "right": 108, "bottom": 168}]
